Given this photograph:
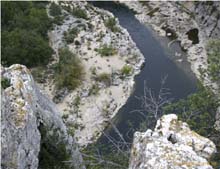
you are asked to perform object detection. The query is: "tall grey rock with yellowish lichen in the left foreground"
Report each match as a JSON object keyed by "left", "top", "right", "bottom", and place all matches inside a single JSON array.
[{"left": 1, "top": 64, "right": 84, "bottom": 169}]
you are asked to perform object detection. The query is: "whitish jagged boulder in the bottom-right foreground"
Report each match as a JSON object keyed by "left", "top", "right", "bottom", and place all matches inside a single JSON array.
[{"left": 129, "top": 114, "right": 216, "bottom": 169}]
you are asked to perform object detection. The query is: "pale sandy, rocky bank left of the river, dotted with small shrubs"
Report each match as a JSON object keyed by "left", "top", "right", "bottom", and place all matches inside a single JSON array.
[{"left": 39, "top": 2, "right": 144, "bottom": 146}]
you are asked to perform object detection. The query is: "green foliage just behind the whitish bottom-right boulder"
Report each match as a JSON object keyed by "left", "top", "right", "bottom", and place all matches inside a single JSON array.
[{"left": 164, "top": 85, "right": 219, "bottom": 136}]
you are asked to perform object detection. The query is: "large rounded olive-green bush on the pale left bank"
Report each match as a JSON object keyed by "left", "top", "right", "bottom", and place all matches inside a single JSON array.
[{"left": 55, "top": 48, "right": 84, "bottom": 90}]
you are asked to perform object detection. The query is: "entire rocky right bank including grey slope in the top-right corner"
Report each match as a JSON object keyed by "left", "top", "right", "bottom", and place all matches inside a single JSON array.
[{"left": 119, "top": 1, "right": 220, "bottom": 130}]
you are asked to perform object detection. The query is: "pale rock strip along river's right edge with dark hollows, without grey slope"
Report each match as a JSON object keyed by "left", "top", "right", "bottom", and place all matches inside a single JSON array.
[{"left": 119, "top": 1, "right": 218, "bottom": 91}]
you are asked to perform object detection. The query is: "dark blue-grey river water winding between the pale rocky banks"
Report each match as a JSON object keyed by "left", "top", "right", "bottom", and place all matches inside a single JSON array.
[{"left": 92, "top": 2, "right": 196, "bottom": 144}]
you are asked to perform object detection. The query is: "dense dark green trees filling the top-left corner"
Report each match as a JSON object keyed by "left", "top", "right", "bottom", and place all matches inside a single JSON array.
[{"left": 1, "top": 1, "right": 52, "bottom": 67}]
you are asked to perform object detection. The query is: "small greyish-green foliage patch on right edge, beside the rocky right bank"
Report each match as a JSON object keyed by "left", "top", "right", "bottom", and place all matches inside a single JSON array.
[{"left": 207, "top": 40, "right": 220, "bottom": 82}]
